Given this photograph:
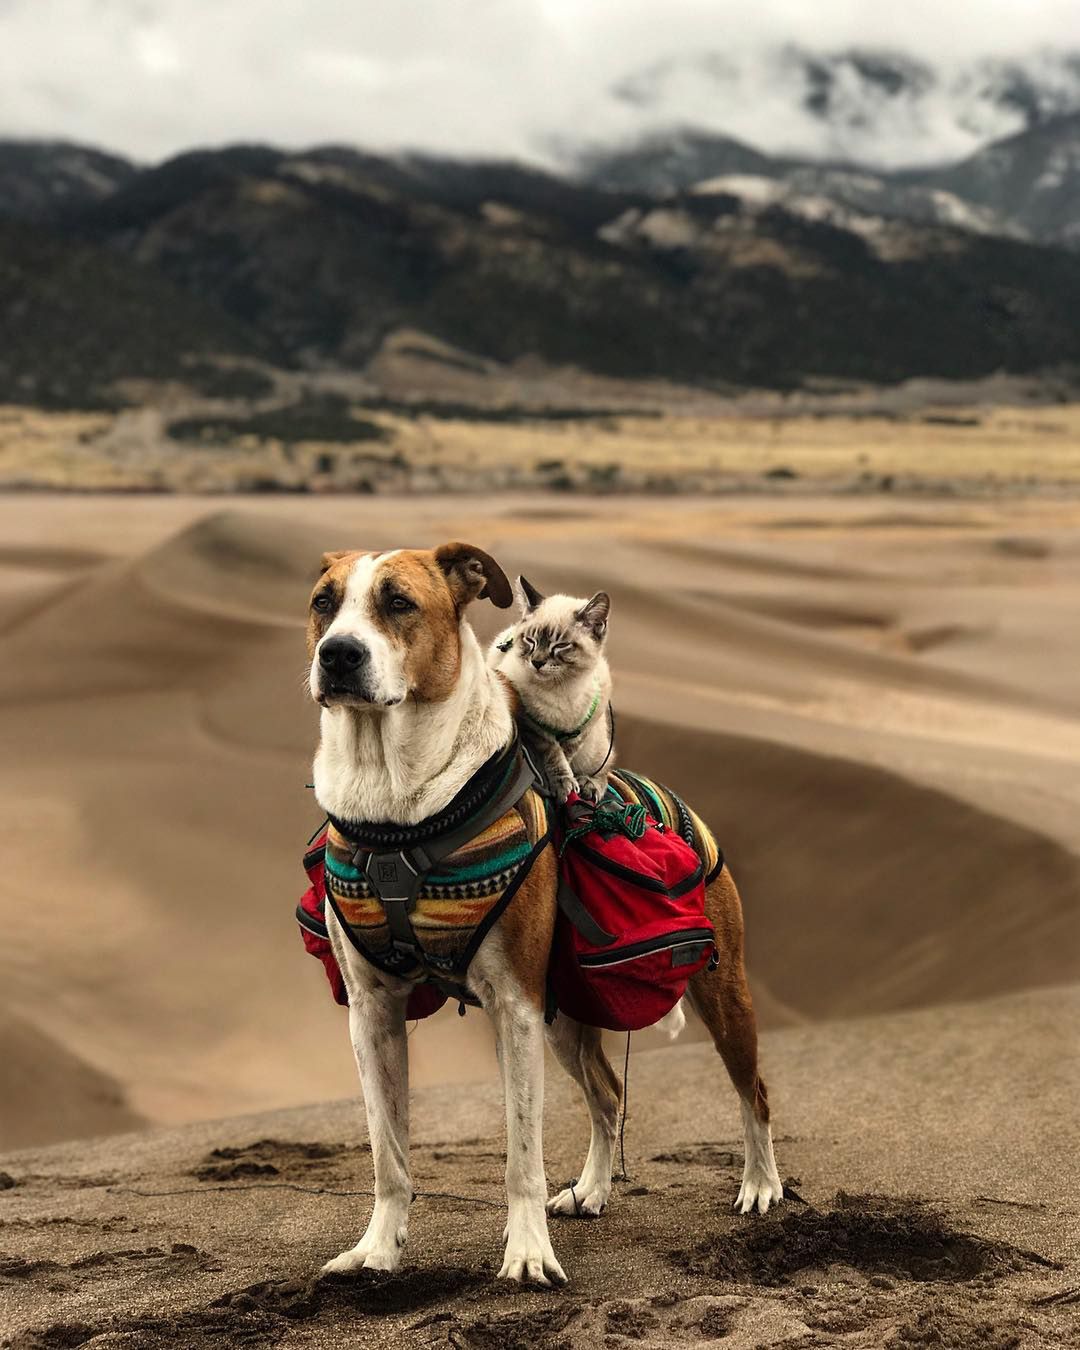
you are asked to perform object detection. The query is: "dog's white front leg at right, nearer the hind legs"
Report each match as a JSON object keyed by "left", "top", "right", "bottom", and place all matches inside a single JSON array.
[{"left": 489, "top": 994, "right": 566, "bottom": 1284}]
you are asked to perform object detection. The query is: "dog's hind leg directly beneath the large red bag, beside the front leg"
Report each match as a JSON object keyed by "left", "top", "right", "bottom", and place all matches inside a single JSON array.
[{"left": 548, "top": 1013, "right": 622, "bottom": 1218}]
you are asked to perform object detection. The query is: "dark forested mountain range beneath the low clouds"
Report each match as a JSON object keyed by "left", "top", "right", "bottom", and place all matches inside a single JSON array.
[{"left": 0, "top": 49, "right": 1080, "bottom": 406}]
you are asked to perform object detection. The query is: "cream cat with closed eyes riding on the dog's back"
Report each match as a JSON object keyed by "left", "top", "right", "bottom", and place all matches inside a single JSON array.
[{"left": 489, "top": 576, "right": 614, "bottom": 802}]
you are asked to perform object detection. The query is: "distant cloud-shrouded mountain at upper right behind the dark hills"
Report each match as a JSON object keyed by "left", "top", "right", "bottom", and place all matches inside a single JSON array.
[{"left": 576, "top": 46, "right": 1080, "bottom": 248}]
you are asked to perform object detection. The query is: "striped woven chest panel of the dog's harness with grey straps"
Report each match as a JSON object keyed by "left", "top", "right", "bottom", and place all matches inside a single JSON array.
[{"left": 310, "top": 741, "right": 551, "bottom": 1003}]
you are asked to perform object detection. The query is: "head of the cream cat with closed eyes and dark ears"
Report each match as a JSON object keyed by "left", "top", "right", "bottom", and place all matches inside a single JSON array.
[{"left": 510, "top": 576, "right": 612, "bottom": 682}]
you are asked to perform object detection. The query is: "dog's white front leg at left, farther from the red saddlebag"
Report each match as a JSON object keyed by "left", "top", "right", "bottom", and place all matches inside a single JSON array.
[{"left": 323, "top": 984, "right": 413, "bottom": 1274}]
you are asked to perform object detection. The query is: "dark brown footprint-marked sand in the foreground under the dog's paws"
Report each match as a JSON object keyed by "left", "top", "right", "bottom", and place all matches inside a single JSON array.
[{"left": 0, "top": 990, "right": 1080, "bottom": 1350}]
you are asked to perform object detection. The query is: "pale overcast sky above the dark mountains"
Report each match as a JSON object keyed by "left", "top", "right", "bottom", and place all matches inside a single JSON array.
[{"left": 0, "top": 0, "right": 1080, "bottom": 159}]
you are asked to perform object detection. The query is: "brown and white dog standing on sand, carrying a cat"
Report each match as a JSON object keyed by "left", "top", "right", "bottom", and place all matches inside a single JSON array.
[{"left": 308, "top": 543, "right": 783, "bottom": 1284}]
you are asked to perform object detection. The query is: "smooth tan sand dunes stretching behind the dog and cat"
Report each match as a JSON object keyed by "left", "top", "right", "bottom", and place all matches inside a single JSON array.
[{"left": 0, "top": 495, "right": 1080, "bottom": 1143}]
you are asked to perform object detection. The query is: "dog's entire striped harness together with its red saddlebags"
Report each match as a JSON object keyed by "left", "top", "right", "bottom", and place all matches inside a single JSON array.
[{"left": 296, "top": 741, "right": 724, "bottom": 1029}]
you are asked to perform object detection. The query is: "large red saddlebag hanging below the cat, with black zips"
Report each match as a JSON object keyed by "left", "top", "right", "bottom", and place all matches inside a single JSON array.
[{"left": 549, "top": 791, "right": 716, "bottom": 1031}]
